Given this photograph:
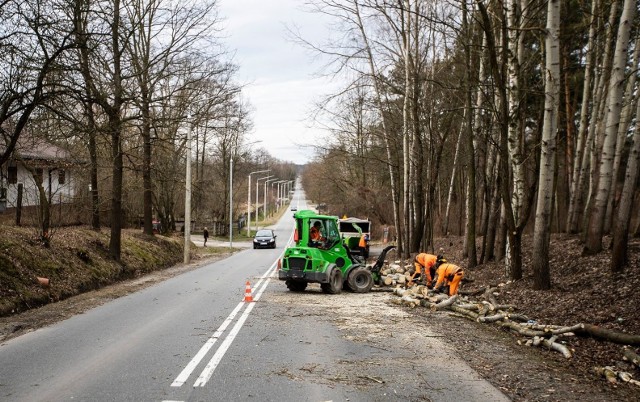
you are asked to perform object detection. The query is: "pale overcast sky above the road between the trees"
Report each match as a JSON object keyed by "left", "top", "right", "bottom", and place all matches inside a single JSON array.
[{"left": 219, "top": 0, "right": 332, "bottom": 164}]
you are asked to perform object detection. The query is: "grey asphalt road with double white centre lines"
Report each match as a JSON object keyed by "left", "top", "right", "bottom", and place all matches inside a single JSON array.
[{"left": 0, "top": 190, "right": 507, "bottom": 402}]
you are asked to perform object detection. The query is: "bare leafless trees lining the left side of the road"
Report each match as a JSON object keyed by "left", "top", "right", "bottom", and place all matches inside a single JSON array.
[{"left": 0, "top": 0, "right": 297, "bottom": 260}]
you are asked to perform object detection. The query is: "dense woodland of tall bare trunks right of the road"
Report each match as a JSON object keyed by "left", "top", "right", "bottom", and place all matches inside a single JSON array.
[{"left": 298, "top": 0, "right": 640, "bottom": 289}]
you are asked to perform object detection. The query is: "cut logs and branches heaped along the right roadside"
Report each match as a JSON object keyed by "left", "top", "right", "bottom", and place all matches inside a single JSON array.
[{"left": 380, "top": 262, "right": 640, "bottom": 386}]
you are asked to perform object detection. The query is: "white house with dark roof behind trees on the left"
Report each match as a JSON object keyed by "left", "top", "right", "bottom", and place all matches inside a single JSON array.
[{"left": 0, "top": 135, "right": 79, "bottom": 212}]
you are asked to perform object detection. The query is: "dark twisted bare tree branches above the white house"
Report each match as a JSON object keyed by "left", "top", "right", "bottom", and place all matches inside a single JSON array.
[{"left": 0, "top": 0, "right": 74, "bottom": 166}]
